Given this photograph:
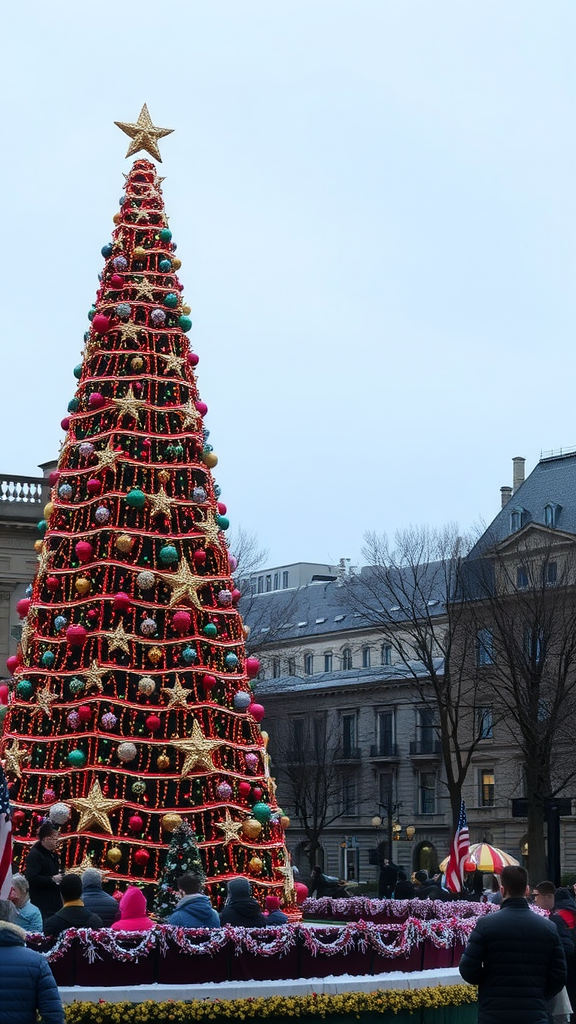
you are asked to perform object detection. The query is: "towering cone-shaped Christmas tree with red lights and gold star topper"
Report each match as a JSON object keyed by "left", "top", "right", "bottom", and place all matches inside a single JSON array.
[{"left": 0, "top": 106, "right": 292, "bottom": 901}]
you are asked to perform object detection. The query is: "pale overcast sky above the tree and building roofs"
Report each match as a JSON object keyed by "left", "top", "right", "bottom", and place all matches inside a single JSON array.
[{"left": 0, "top": 0, "right": 576, "bottom": 565}]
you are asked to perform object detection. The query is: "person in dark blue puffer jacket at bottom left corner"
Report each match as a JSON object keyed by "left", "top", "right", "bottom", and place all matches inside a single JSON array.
[{"left": 0, "top": 899, "right": 64, "bottom": 1024}]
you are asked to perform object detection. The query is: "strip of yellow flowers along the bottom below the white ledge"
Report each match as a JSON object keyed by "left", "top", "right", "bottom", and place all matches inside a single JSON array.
[{"left": 66, "top": 985, "right": 478, "bottom": 1024}]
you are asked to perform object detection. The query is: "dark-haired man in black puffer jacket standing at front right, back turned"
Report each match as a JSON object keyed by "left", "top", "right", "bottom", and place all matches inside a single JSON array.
[{"left": 460, "top": 867, "right": 566, "bottom": 1024}]
